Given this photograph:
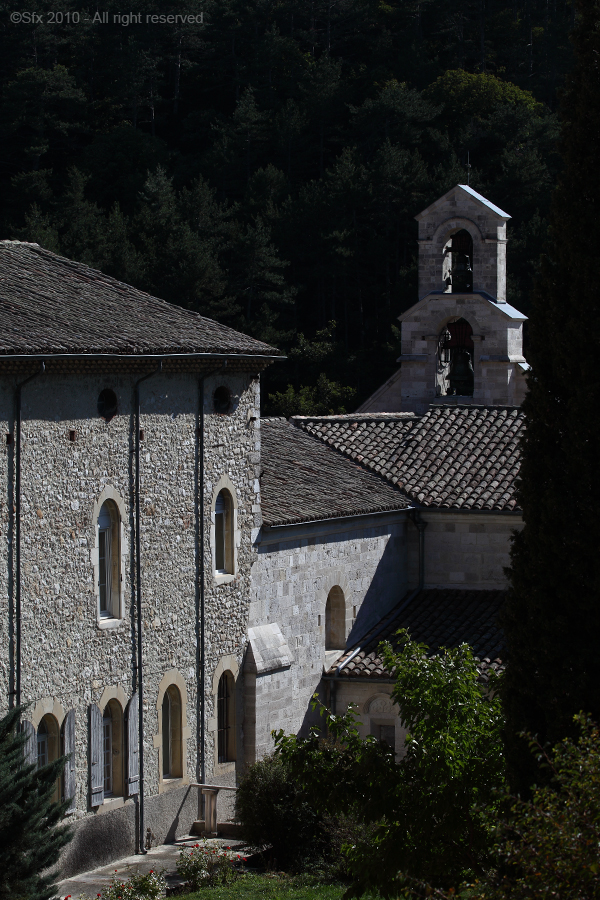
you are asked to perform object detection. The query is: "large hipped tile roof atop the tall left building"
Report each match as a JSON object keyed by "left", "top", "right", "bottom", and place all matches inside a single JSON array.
[{"left": 0, "top": 241, "right": 278, "bottom": 356}]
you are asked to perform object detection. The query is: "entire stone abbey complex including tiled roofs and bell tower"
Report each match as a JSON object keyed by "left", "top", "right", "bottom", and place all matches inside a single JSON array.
[{"left": 0, "top": 185, "right": 528, "bottom": 877}]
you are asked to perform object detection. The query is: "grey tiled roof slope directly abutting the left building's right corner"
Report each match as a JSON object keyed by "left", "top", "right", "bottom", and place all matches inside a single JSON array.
[{"left": 260, "top": 419, "right": 409, "bottom": 526}]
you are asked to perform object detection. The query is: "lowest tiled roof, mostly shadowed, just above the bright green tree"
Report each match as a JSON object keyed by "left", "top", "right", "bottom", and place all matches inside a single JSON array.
[{"left": 327, "top": 588, "right": 506, "bottom": 679}]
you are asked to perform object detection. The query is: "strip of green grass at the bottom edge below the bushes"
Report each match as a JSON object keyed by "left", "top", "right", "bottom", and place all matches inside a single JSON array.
[{"left": 177, "top": 874, "right": 345, "bottom": 900}]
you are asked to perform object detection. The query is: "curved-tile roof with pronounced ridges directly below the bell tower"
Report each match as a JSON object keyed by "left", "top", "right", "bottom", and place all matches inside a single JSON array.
[{"left": 291, "top": 405, "right": 524, "bottom": 510}]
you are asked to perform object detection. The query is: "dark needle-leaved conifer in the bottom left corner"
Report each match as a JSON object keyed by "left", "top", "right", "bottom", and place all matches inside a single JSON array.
[{"left": 0, "top": 707, "right": 71, "bottom": 900}]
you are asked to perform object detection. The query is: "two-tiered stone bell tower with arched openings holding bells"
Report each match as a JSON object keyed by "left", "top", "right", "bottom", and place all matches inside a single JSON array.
[{"left": 358, "top": 184, "right": 529, "bottom": 413}]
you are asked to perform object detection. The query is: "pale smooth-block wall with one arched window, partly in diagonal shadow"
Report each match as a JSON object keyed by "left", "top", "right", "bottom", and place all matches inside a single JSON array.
[{"left": 246, "top": 513, "right": 412, "bottom": 758}]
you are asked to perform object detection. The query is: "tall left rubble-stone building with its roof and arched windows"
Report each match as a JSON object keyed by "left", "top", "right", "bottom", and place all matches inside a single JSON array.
[{"left": 0, "top": 241, "right": 277, "bottom": 875}]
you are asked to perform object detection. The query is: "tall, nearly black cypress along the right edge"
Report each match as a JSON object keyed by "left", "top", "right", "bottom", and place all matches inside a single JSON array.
[{"left": 503, "top": 0, "right": 600, "bottom": 790}]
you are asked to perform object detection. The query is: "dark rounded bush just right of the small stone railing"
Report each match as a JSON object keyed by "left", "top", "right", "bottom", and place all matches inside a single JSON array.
[{"left": 235, "top": 754, "right": 323, "bottom": 869}]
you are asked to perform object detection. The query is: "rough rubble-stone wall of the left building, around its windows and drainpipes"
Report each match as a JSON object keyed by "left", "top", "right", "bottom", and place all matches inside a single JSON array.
[{"left": 0, "top": 374, "right": 259, "bottom": 873}]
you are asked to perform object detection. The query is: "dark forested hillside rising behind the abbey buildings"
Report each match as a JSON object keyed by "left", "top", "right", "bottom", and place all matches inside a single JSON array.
[{"left": 0, "top": 0, "right": 574, "bottom": 415}]
